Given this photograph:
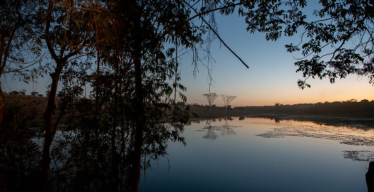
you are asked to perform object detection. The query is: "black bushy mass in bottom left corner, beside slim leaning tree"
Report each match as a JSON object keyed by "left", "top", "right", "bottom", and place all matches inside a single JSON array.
[{"left": 0, "top": 105, "right": 40, "bottom": 191}]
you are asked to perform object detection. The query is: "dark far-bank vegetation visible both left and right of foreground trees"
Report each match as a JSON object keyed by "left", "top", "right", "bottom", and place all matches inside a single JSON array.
[{"left": 4, "top": 94, "right": 374, "bottom": 127}]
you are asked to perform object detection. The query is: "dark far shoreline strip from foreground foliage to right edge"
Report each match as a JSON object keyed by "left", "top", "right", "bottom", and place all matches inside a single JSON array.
[{"left": 191, "top": 99, "right": 374, "bottom": 120}]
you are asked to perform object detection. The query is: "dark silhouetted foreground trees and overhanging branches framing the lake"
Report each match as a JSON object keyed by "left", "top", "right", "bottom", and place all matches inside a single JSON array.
[{"left": 0, "top": 0, "right": 374, "bottom": 191}]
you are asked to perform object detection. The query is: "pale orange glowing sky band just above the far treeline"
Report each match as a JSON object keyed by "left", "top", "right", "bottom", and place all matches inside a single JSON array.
[{"left": 186, "top": 76, "right": 374, "bottom": 107}]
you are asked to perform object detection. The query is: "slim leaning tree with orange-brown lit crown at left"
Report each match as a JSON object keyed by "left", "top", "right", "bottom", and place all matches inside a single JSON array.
[{"left": 41, "top": 0, "right": 98, "bottom": 190}]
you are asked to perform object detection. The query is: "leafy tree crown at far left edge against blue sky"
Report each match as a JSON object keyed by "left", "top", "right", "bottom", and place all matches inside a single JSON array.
[{"left": 0, "top": 0, "right": 42, "bottom": 126}]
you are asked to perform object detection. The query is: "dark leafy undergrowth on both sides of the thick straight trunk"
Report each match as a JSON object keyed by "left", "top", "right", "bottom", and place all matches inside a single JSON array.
[{"left": 47, "top": 51, "right": 188, "bottom": 191}]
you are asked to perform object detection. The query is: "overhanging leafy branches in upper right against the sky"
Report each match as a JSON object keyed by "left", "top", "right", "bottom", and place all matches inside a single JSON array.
[{"left": 243, "top": 0, "right": 374, "bottom": 89}]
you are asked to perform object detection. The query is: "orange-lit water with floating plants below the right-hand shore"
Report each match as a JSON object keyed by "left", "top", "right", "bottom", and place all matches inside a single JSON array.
[{"left": 256, "top": 119, "right": 374, "bottom": 162}]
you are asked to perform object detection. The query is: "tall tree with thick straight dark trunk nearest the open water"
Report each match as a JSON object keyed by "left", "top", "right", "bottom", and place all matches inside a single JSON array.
[{"left": 114, "top": 0, "right": 199, "bottom": 191}]
